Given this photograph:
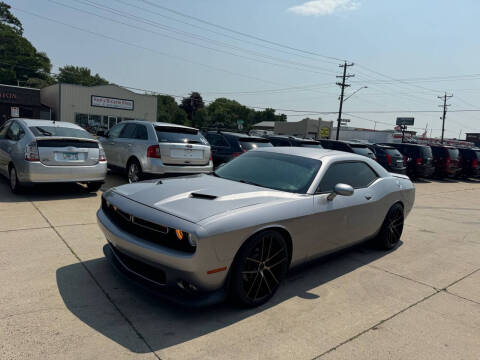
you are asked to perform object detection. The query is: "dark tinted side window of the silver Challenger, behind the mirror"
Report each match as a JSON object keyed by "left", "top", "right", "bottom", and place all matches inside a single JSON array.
[{"left": 317, "top": 161, "right": 378, "bottom": 193}]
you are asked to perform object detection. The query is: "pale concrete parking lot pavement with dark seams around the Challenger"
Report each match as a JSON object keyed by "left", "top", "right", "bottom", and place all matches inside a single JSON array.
[{"left": 0, "top": 175, "right": 480, "bottom": 359}]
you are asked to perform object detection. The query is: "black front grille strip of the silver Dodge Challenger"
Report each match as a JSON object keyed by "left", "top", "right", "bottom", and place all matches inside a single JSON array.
[{"left": 102, "top": 197, "right": 196, "bottom": 253}]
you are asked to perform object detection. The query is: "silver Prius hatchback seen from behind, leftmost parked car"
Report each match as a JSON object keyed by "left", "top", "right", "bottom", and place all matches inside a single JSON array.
[{"left": 0, "top": 119, "right": 107, "bottom": 192}]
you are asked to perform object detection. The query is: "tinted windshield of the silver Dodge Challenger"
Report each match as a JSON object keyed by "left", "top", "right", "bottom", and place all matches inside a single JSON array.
[{"left": 214, "top": 151, "right": 322, "bottom": 194}]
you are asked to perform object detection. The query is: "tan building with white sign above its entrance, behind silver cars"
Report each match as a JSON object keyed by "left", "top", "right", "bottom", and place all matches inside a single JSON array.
[{"left": 40, "top": 84, "right": 157, "bottom": 132}]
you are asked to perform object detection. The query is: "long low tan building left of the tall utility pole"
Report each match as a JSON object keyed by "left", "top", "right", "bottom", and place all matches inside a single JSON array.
[{"left": 275, "top": 118, "right": 333, "bottom": 139}]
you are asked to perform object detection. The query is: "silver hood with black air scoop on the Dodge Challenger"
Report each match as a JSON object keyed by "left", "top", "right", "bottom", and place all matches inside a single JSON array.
[{"left": 112, "top": 175, "right": 301, "bottom": 223}]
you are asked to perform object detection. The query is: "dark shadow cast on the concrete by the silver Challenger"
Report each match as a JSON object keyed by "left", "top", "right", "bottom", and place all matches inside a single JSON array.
[{"left": 56, "top": 243, "right": 401, "bottom": 353}]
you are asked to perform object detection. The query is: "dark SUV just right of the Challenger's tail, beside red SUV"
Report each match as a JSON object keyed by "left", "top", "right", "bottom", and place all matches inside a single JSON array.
[{"left": 383, "top": 143, "right": 435, "bottom": 179}]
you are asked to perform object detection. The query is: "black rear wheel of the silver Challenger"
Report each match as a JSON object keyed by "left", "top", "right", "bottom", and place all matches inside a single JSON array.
[{"left": 375, "top": 203, "right": 404, "bottom": 250}]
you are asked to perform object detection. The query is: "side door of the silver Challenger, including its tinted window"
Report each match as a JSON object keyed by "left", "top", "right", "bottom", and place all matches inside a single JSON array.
[{"left": 311, "top": 161, "right": 379, "bottom": 256}]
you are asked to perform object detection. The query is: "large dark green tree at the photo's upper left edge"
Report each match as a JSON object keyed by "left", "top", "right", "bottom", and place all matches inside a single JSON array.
[{"left": 0, "top": 22, "right": 54, "bottom": 86}]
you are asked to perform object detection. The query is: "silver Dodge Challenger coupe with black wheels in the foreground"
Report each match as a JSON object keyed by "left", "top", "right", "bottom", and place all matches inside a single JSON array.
[{"left": 97, "top": 147, "right": 415, "bottom": 306}]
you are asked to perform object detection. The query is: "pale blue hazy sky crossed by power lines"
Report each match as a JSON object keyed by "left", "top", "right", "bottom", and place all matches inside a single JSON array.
[{"left": 6, "top": 0, "right": 480, "bottom": 138}]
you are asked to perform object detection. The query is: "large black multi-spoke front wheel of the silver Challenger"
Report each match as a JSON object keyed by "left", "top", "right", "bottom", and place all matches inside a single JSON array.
[{"left": 230, "top": 230, "right": 289, "bottom": 307}]
